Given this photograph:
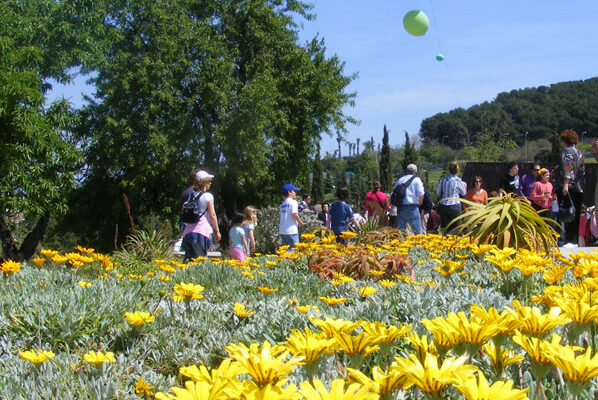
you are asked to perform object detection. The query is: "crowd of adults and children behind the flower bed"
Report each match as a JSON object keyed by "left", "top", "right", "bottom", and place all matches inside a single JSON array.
[{"left": 179, "top": 130, "right": 598, "bottom": 261}]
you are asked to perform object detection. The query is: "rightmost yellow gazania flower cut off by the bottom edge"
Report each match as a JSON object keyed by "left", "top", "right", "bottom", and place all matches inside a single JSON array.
[{"left": 453, "top": 371, "right": 529, "bottom": 400}]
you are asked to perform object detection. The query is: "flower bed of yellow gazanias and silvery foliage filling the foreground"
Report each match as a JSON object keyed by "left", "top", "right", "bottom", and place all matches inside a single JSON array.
[{"left": 0, "top": 235, "right": 598, "bottom": 399}]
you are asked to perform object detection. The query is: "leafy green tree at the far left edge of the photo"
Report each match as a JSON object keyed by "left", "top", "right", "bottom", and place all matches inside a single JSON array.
[{"left": 0, "top": 0, "right": 101, "bottom": 260}]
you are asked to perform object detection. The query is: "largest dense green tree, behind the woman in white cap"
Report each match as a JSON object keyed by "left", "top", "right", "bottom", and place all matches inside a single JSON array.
[{"left": 65, "top": 0, "right": 354, "bottom": 247}]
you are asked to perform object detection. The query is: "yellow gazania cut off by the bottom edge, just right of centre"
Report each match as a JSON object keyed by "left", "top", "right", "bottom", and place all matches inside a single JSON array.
[{"left": 300, "top": 379, "right": 380, "bottom": 400}]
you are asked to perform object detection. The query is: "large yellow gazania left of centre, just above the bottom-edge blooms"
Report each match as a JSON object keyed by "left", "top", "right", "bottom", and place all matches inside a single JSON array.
[{"left": 225, "top": 341, "right": 303, "bottom": 385}]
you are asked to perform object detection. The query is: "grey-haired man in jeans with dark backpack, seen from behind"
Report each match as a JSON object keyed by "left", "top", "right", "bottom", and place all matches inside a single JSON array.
[{"left": 390, "top": 164, "right": 424, "bottom": 235}]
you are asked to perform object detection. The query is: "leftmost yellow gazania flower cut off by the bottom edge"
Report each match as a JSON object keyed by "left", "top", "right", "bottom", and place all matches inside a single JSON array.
[{"left": 156, "top": 380, "right": 242, "bottom": 400}]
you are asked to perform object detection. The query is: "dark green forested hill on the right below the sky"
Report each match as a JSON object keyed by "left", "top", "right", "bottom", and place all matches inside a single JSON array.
[{"left": 420, "top": 78, "right": 598, "bottom": 148}]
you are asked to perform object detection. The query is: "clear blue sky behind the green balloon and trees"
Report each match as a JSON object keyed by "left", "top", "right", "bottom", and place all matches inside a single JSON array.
[{"left": 54, "top": 0, "right": 598, "bottom": 153}]
